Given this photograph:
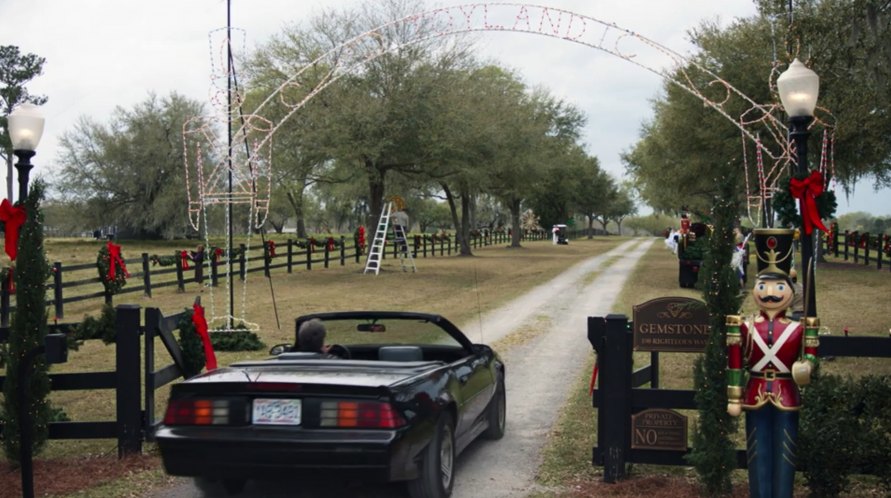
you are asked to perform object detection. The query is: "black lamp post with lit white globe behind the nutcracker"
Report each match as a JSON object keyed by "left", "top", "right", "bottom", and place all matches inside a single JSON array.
[{"left": 777, "top": 59, "right": 820, "bottom": 317}]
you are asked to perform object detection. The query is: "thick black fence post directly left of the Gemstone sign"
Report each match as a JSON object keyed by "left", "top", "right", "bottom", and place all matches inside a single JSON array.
[{"left": 588, "top": 314, "right": 631, "bottom": 482}]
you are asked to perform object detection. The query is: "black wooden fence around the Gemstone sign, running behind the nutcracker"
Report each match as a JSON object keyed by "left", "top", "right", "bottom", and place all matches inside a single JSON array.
[{"left": 588, "top": 315, "right": 891, "bottom": 482}]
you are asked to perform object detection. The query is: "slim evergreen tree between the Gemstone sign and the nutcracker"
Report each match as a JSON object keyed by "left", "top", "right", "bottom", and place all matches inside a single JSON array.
[{"left": 688, "top": 177, "right": 742, "bottom": 496}]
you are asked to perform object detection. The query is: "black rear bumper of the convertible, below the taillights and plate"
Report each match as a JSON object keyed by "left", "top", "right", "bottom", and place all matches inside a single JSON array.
[{"left": 155, "top": 426, "right": 426, "bottom": 481}]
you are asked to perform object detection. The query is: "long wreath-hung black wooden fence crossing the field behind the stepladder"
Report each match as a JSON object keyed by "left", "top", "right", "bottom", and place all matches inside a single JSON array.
[{"left": 0, "top": 231, "right": 546, "bottom": 327}]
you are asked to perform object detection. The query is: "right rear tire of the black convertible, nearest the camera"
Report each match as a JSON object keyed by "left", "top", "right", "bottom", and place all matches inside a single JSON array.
[{"left": 408, "top": 413, "right": 455, "bottom": 498}]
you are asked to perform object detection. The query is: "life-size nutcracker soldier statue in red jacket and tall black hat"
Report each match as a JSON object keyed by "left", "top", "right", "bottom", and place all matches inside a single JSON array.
[{"left": 727, "top": 229, "right": 819, "bottom": 498}]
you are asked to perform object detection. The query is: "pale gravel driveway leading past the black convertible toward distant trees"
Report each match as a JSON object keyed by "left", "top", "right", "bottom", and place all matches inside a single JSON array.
[{"left": 154, "top": 239, "right": 655, "bottom": 498}]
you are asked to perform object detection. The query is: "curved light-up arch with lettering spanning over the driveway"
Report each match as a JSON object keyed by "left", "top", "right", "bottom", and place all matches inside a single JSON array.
[{"left": 186, "top": 3, "right": 824, "bottom": 223}]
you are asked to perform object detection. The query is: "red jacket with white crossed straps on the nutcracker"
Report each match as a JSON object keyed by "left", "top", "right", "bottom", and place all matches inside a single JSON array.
[{"left": 727, "top": 313, "right": 817, "bottom": 411}]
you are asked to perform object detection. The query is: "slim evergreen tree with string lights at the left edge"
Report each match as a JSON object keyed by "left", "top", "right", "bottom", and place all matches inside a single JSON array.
[{"left": 3, "top": 181, "right": 50, "bottom": 462}]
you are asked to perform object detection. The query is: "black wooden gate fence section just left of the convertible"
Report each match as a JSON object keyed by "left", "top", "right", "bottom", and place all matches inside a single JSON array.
[{"left": 0, "top": 304, "right": 194, "bottom": 456}]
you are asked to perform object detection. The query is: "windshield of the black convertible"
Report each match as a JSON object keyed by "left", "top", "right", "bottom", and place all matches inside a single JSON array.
[{"left": 304, "top": 317, "right": 461, "bottom": 347}]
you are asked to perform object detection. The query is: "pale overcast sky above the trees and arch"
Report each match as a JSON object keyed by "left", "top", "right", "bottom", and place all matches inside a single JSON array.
[{"left": 0, "top": 0, "right": 891, "bottom": 215}]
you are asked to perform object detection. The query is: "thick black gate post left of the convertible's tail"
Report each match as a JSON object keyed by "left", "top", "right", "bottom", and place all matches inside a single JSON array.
[{"left": 115, "top": 304, "right": 142, "bottom": 458}]
